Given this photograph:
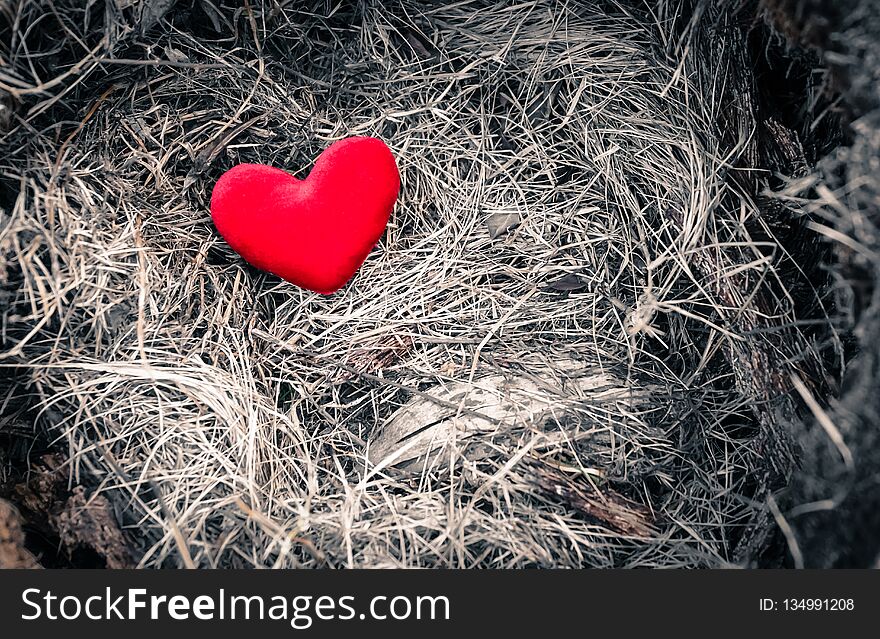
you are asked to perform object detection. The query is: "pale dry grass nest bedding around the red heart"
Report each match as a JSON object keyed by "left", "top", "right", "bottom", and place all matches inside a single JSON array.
[{"left": 0, "top": 0, "right": 838, "bottom": 568}]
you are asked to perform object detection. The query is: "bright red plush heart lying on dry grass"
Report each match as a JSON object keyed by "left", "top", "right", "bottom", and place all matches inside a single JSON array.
[{"left": 211, "top": 137, "right": 400, "bottom": 294}]
